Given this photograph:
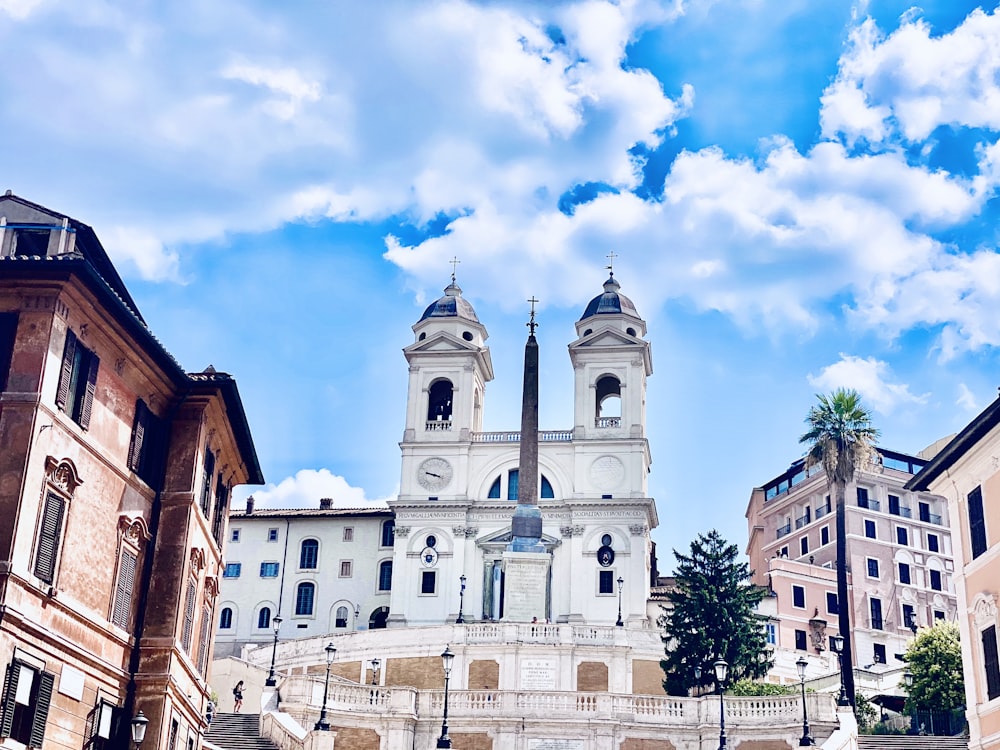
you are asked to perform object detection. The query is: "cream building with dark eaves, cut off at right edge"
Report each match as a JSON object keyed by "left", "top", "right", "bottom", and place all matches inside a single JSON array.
[{"left": 906, "top": 399, "right": 1000, "bottom": 750}]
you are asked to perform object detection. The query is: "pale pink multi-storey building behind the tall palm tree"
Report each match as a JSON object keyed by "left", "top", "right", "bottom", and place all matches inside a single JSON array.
[{"left": 746, "top": 448, "right": 957, "bottom": 692}]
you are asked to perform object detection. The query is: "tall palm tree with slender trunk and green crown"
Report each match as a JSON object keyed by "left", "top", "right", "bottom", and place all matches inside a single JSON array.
[{"left": 799, "top": 388, "right": 879, "bottom": 706}]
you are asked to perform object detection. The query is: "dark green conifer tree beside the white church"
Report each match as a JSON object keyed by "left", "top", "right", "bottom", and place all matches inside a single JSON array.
[{"left": 659, "top": 529, "right": 771, "bottom": 695}]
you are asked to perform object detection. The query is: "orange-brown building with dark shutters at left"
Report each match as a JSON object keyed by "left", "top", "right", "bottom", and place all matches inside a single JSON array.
[{"left": 0, "top": 192, "right": 263, "bottom": 750}]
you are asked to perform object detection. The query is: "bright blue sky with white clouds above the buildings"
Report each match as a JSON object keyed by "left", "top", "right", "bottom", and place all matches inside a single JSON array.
[{"left": 0, "top": 0, "right": 1000, "bottom": 572}]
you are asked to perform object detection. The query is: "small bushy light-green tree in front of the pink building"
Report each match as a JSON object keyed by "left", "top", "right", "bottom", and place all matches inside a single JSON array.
[{"left": 904, "top": 621, "right": 965, "bottom": 713}]
